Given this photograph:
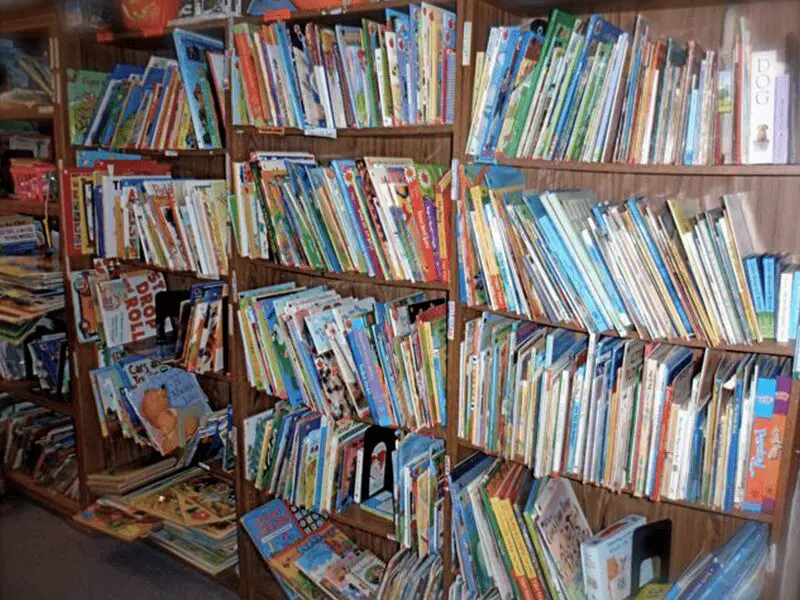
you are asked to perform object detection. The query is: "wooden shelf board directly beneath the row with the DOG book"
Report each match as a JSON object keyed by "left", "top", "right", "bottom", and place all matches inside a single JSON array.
[{"left": 484, "top": 158, "right": 800, "bottom": 177}]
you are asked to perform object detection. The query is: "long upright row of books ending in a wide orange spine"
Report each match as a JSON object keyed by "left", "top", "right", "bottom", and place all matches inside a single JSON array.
[{"left": 458, "top": 314, "right": 791, "bottom": 513}]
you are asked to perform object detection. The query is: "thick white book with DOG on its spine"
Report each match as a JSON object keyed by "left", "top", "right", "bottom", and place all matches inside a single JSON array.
[{"left": 747, "top": 50, "right": 784, "bottom": 165}]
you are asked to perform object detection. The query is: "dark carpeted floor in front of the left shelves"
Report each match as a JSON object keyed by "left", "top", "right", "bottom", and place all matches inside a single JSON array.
[{"left": 0, "top": 495, "right": 237, "bottom": 600}]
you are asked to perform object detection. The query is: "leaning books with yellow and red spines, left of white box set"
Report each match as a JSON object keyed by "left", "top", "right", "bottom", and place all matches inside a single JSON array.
[{"left": 450, "top": 454, "right": 592, "bottom": 598}]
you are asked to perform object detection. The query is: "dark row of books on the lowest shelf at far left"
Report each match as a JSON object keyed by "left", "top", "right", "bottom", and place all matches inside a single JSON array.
[{"left": 0, "top": 395, "right": 80, "bottom": 500}]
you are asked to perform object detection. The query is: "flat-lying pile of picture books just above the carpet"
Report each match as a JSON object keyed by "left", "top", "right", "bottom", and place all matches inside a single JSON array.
[{"left": 73, "top": 468, "right": 239, "bottom": 575}]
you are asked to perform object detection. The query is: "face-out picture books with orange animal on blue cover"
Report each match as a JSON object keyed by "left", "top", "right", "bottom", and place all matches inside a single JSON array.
[{"left": 90, "top": 355, "right": 212, "bottom": 455}]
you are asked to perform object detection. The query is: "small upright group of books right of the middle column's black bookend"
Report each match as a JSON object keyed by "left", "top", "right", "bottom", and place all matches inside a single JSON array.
[{"left": 392, "top": 434, "right": 445, "bottom": 558}]
